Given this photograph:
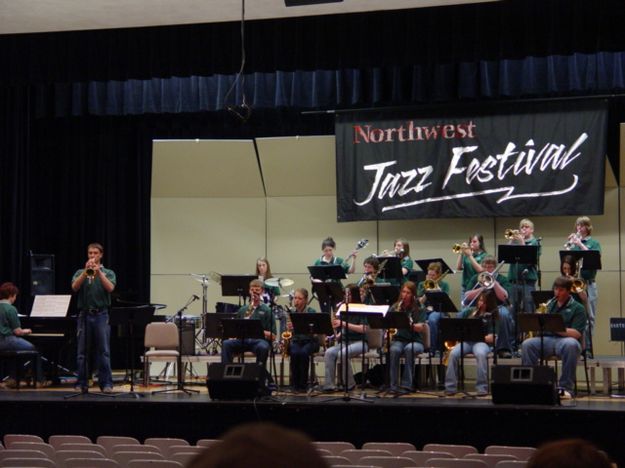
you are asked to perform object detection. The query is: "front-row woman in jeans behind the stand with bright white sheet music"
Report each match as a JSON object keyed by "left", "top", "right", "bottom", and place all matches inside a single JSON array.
[{"left": 323, "top": 285, "right": 369, "bottom": 391}]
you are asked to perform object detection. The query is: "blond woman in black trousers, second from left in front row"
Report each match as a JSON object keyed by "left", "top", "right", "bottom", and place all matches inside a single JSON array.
[{"left": 287, "top": 288, "right": 319, "bottom": 391}]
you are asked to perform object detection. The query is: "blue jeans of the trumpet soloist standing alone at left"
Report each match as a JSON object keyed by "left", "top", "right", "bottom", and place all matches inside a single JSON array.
[{"left": 76, "top": 309, "right": 113, "bottom": 389}]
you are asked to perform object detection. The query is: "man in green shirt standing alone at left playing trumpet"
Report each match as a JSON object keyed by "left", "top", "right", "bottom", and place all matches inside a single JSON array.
[{"left": 72, "top": 243, "right": 116, "bottom": 393}]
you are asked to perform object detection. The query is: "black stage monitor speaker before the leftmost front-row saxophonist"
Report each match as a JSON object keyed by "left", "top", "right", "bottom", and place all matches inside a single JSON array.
[{"left": 206, "top": 362, "right": 271, "bottom": 400}]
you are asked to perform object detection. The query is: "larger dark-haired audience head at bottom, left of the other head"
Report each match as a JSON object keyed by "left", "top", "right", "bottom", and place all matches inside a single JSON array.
[{"left": 187, "top": 422, "right": 328, "bottom": 468}]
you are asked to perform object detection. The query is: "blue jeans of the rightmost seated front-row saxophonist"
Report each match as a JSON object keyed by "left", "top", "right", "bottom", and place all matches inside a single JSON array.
[{"left": 522, "top": 336, "right": 582, "bottom": 392}]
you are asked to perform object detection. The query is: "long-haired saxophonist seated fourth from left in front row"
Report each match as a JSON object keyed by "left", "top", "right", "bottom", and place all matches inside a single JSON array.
[{"left": 389, "top": 281, "right": 426, "bottom": 392}]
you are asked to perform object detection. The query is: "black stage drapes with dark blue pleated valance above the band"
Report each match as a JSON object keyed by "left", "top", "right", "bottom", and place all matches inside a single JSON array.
[{"left": 0, "top": 0, "right": 625, "bottom": 308}]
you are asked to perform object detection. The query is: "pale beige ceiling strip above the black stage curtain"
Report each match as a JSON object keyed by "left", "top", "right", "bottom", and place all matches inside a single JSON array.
[{"left": 0, "top": 0, "right": 497, "bottom": 34}]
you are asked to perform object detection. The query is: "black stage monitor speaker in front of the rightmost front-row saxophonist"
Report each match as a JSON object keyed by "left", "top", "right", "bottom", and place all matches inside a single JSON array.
[{"left": 491, "top": 366, "right": 559, "bottom": 405}]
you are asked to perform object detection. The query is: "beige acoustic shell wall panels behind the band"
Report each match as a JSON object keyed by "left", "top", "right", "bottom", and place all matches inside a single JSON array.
[{"left": 151, "top": 137, "right": 625, "bottom": 355}]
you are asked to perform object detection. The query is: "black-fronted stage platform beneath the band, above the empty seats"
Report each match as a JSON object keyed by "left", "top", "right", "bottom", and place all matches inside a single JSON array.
[{"left": 0, "top": 382, "right": 625, "bottom": 466}]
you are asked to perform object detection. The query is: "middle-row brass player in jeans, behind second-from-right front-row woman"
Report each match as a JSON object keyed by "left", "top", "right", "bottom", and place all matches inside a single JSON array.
[{"left": 464, "top": 255, "right": 516, "bottom": 358}]
